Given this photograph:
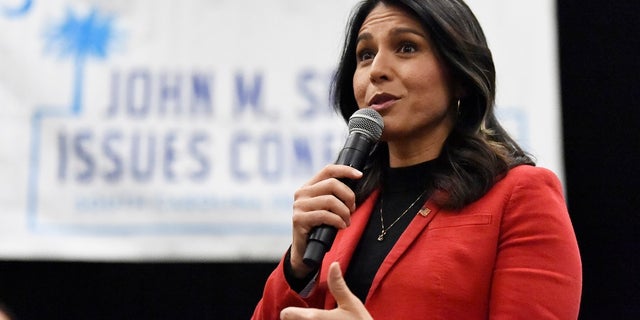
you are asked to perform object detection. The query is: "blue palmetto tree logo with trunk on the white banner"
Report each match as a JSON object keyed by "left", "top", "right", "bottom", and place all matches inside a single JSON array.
[{"left": 45, "top": 9, "right": 115, "bottom": 114}]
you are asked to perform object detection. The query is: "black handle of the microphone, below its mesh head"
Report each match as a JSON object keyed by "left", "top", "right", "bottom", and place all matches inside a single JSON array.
[{"left": 302, "top": 132, "right": 375, "bottom": 269}]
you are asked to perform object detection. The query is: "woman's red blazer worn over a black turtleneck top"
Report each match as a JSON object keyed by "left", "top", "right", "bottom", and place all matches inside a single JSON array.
[{"left": 252, "top": 166, "right": 582, "bottom": 320}]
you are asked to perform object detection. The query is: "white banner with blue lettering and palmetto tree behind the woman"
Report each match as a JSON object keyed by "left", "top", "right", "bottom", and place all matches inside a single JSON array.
[{"left": 0, "top": 0, "right": 562, "bottom": 261}]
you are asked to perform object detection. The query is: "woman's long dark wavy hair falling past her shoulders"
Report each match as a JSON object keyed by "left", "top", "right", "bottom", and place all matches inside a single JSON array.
[{"left": 331, "top": 0, "right": 535, "bottom": 209}]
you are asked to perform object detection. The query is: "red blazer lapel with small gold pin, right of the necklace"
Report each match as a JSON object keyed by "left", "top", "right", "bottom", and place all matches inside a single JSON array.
[{"left": 367, "top": 199, "right": 439, "bottom": 300}]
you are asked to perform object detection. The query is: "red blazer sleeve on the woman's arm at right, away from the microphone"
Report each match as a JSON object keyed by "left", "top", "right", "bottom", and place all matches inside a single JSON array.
[{"left": 489, "top": 166, "right": 582, "bottom": 319}]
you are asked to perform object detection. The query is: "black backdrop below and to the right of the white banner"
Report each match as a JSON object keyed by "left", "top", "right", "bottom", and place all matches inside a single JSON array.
[{"left": 0, "top": 0, "right": 640, "bottom": 319}]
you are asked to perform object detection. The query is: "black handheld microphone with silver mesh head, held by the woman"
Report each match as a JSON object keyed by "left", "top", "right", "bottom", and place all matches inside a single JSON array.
[{"left": 302, "top": 108, "right": 384, "bottom": 268}]
